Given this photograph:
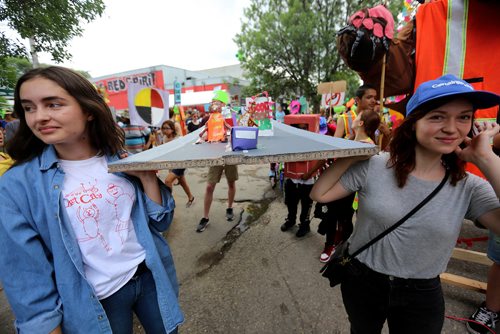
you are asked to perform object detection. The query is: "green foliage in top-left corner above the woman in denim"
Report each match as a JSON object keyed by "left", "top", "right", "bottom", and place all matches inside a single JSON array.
[{"left": 0, "top": 0, "right": 104, "bottom": 62}]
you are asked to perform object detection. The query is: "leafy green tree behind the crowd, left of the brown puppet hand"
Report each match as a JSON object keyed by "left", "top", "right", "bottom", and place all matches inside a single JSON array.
[{"left": 235, "top": 0, "right": 398, "bottom": 106}]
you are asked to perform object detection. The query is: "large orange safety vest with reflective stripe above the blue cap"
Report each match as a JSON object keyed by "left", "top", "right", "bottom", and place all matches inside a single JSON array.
[{"left": 415, "top": 0, "right": 500, "bottom": 121}]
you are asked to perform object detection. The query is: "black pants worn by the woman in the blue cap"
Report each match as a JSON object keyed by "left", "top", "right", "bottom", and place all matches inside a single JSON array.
[{"left": 341, "top": 260, "right": 444, "bottom": 334}]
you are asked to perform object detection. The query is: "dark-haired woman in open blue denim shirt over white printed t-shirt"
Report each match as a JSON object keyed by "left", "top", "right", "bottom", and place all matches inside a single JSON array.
[{"left": 0, "top": 67, "right": 183, "bottom": 333}]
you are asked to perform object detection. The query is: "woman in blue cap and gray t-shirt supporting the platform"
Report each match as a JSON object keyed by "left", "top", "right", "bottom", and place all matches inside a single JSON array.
[{"left": 311, "top": 75, "right": 500, "bottom": 334}]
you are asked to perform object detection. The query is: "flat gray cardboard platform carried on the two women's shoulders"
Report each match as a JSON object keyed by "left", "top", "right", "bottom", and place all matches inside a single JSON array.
[{"left": 109, "top": 120, "right": 378, "bottom": 172}]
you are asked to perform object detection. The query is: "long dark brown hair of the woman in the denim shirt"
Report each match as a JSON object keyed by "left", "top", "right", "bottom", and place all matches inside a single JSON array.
[{"left": 7, "top": 66, "right": 124, "bottom": 165}]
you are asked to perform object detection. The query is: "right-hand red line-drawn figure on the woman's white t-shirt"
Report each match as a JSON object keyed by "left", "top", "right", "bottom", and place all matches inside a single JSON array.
[{"left": 106, "top": 183, "right": 134, "bottom": 245}]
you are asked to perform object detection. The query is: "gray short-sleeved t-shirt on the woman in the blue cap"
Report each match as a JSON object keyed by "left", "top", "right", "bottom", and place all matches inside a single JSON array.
[{"left": 340, "top": 153, "right": 500, "bottom": 278}]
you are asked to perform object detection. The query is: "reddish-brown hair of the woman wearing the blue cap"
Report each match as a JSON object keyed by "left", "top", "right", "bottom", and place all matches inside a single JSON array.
[{"left": 388, "top": 98, "right": 474, "bottom": 188}]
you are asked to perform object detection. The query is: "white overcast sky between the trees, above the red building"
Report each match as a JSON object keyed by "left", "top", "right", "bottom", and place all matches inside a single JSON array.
[{"left": 40, "top": 0, "right": 250, "bottom": 77}]
